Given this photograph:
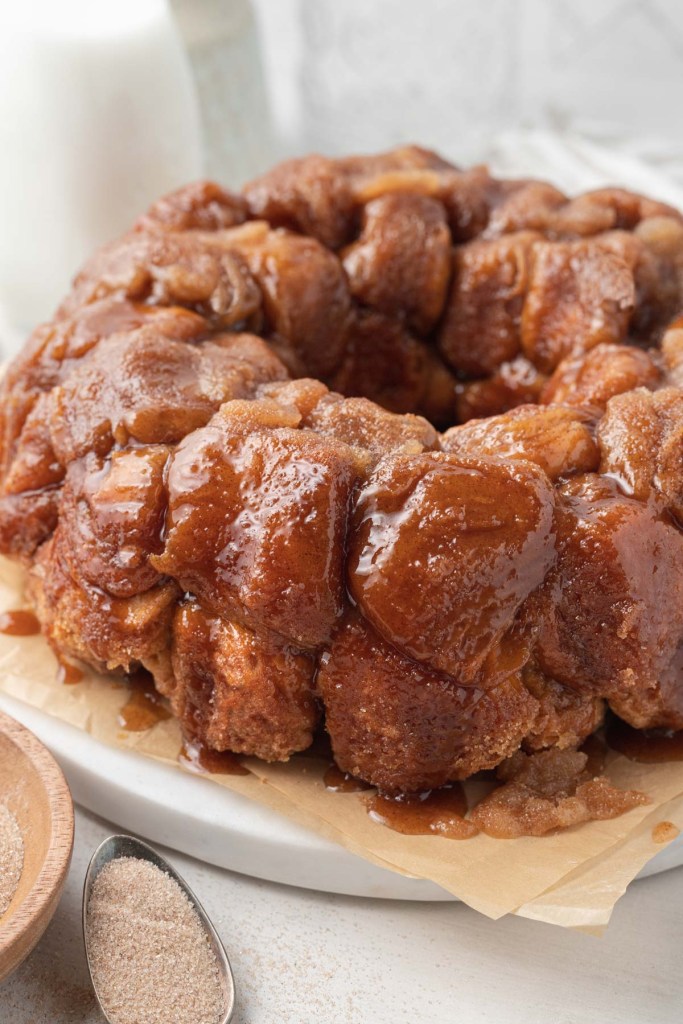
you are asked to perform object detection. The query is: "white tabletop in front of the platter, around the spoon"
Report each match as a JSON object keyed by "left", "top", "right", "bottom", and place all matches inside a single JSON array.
[{"left": 0, "top": 810, "right": 683, "bottom": 1024}]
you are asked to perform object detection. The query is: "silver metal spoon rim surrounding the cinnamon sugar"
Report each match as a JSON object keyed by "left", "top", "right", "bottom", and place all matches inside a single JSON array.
[{"left": 83, "top": 836, "right": 234, "bottom": 1024}]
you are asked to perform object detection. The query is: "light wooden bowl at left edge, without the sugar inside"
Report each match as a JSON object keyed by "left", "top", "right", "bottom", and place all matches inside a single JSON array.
[{"left": 0, "top": 712, "right": 74, "bottom": 981}]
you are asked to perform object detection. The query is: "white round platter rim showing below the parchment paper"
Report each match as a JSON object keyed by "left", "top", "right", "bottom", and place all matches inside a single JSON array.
[{"left": 0, "top": 694, "right": 683, "bottom": 900}]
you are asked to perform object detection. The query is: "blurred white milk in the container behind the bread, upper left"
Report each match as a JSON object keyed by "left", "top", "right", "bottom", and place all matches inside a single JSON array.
[{"left": 0, "top": 0, "right": 203, "bottom": 327}]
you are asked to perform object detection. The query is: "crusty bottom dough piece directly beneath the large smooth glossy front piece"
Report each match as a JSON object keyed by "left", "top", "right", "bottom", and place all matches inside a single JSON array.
[{"left": 317, "top": 612, "right": 539, "bottom": 792}]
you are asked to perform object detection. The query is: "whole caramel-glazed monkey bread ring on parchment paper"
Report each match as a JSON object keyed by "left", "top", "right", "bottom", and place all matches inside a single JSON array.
[{"left": 0, "top": 147, "right": 683, "bottom": 793}]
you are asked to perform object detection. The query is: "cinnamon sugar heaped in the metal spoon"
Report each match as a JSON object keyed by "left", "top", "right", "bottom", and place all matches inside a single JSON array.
[{"left": 86, "top": 857, "right": 225, "bottom": 1024}]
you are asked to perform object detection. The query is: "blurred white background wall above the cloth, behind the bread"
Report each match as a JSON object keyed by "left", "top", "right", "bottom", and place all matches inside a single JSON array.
[{"left": 253, "top": 0, "right": 683, "bottom": 183}]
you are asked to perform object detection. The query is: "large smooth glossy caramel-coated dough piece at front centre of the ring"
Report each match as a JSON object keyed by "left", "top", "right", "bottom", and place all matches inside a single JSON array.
[{"left": 348, "top": 452, "right": 555, "bottom": 684}]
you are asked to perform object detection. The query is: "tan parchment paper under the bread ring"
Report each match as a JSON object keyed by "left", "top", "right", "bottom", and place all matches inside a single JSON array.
[{"left": 0, "top": 559, "right": 683, "bottom": 931}]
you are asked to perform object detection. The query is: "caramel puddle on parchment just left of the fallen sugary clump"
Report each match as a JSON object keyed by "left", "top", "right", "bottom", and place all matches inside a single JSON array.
[{"left": 367, "top": 782, "right": 479, "bottom": 839}]
